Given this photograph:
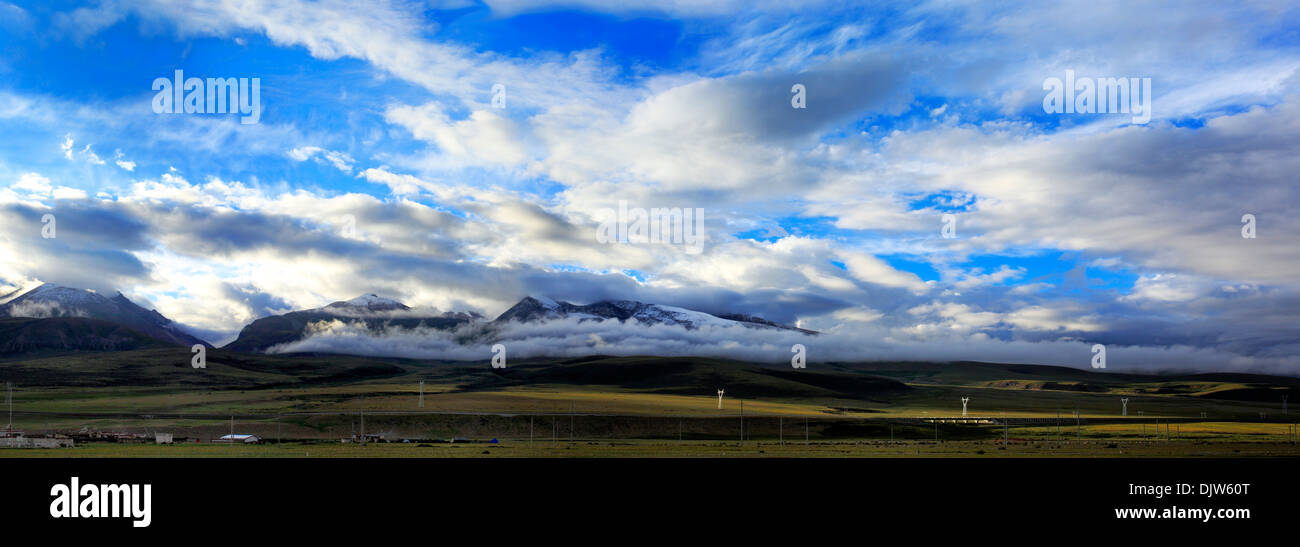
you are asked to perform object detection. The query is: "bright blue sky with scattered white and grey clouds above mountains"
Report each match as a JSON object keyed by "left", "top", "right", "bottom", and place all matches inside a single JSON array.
[{"left": 0, "top": 0, "right": 1300, "bottom": 372}]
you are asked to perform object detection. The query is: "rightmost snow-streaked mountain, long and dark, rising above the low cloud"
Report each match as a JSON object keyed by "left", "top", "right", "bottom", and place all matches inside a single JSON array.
[{"left": 495, "top": 296, "right": 816, "bottom": 334}]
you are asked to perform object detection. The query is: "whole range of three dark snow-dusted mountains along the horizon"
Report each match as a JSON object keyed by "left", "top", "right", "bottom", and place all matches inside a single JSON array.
[{"left": 0, "top": 283, "right": 818, "bottom": 353}]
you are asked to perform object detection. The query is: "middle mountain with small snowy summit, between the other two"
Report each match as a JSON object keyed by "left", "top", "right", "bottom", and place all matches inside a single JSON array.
[{"left": 225, "top": 294, "right": 484, "bottom": 352}]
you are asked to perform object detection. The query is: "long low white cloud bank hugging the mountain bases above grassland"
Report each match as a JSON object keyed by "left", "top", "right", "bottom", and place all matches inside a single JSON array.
[{"left": 269, "top": 318, "right": 1300, "bottom": 374}]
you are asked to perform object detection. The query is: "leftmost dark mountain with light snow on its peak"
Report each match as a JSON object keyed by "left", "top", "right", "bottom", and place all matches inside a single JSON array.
[{"left": 0, "top": 283, "right": 207, "bottom": 346}]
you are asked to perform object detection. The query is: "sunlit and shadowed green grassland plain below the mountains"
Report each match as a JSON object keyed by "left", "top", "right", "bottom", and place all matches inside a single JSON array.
[{"left": 0, "top": 348, "right": 1300, "bottom": 457}]
